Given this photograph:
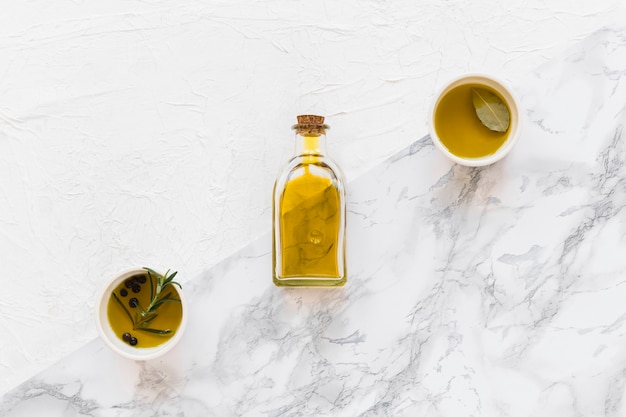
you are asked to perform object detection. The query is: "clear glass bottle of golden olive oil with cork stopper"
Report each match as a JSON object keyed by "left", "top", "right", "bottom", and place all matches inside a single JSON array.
[{"left": 272, "top": 115, "right": 346, "bottom": 287}]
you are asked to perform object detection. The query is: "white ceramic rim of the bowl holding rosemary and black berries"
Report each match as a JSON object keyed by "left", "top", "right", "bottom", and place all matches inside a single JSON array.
[{"left": 96, "top": 268, "right": 188, "bottom": 361}]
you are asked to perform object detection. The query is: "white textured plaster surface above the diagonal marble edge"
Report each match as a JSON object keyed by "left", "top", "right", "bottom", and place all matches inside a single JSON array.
[{"left": 0, "top": 0, "right": 626, "bottom": 393}]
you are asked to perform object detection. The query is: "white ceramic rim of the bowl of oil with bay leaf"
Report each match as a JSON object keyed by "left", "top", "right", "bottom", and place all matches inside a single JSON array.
[{"left": 429, "top": 74, "right": 522, "bottom": 167}]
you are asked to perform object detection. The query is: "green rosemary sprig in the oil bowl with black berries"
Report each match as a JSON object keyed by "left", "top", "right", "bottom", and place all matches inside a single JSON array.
[{"left": 112, "top": 267, "right": 182, "bottom": 335}]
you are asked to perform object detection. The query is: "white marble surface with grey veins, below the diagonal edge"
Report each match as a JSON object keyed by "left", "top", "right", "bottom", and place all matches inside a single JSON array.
[{"left": 0, "top": 28, "right": 626, "bottom": 417}]
